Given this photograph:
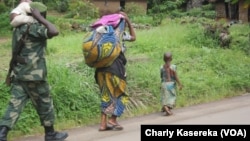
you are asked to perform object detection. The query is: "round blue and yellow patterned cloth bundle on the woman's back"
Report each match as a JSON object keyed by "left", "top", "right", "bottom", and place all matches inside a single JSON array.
[{"left": 83, "top": 19, "right": 125, "bottom": 68}]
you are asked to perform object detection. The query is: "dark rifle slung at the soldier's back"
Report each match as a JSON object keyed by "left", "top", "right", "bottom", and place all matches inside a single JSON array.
[{"left": 5, "top": 25, "right": 29, "bottom": 86}]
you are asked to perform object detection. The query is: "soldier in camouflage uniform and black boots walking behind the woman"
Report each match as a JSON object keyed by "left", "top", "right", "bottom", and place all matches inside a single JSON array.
[{"left": 0, "top": 2, "right": 68, "bottom": 141}]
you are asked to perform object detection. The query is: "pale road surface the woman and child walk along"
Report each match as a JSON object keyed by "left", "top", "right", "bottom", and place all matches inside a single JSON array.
[{"left": 15, "top": 94, "right": 250, "bottom": 141}]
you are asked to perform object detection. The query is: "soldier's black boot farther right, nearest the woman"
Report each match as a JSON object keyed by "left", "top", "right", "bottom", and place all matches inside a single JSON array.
[{"left": 45, "top": 131, "right": 68, "bottom": 141}]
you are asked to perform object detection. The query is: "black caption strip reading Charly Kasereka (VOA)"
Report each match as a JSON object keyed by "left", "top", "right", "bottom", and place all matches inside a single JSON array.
[{"left": 141, "top": 124, "right": 250, "bottom": 141}]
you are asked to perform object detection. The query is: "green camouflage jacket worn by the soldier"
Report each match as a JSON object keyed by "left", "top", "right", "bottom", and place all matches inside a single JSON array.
[{"left": 12, "top": 23, "right": 48, "bottom": 81}]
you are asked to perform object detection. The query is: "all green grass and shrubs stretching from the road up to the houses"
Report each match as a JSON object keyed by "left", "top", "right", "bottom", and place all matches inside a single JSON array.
[{"left": 0, "top": 0, "right": 250, "bottom": 138}]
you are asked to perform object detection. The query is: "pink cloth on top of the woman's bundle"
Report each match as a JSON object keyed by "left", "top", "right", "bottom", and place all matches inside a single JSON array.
[{"left": 91, "top": 14, "right": 124, "bottom": 28}]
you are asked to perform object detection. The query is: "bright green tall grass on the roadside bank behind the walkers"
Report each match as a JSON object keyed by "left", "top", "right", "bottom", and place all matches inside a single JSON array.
[{"left": 0, "top": 19, "right": 250, "bottom": 139}]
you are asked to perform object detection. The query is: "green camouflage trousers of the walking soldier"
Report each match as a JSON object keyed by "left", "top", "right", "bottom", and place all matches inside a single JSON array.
[{"left": 0, "top": 81, "right": 55, "bottom": 129}]
